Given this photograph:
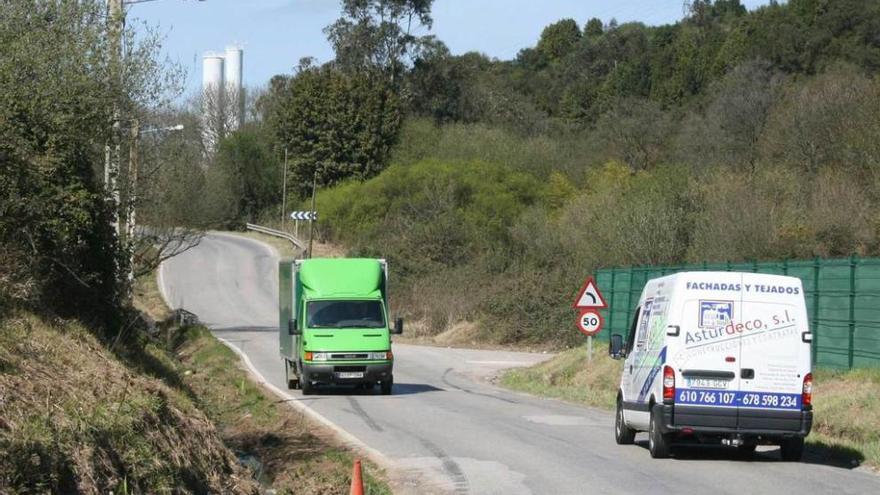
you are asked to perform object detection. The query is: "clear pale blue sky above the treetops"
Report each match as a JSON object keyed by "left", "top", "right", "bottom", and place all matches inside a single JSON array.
[{"left": 128, "top": 0, "right": 767, "bottom": 95}]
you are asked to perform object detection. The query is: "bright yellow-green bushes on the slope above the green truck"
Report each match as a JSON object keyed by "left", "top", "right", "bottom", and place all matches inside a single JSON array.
[{"left": 318, "top": 160, "right": 539, "bottom": 273}]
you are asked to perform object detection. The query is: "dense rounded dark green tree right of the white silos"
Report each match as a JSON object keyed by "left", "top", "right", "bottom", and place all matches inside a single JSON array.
[{"left": 264, "top": 66, "right": 401, "bottom": 196}]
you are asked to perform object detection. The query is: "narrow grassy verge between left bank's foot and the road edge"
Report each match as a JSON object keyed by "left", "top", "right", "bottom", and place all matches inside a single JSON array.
[{"left": 175, "top": 327, "right": 391, "bottom": 494}]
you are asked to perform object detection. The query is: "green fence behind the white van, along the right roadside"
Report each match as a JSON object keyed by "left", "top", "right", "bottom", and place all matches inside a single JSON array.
[{"left": 596, "top": 257, "right": 880, "bottom": 368}]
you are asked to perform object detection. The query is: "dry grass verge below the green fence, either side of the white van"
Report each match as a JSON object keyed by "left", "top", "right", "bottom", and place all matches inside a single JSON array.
[{"left": 501, "top": 345, "right": 880, "bottom": 470}]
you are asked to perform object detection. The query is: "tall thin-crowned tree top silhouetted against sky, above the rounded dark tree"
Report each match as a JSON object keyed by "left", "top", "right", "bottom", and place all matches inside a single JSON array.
[{"left": 324, "top": 0, "right": 433, "bottom": 84}]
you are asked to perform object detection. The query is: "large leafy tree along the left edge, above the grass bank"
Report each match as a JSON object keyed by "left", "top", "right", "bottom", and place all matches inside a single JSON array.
[{"left": 0, "top": 0, "right": 180, "bottom": 323}]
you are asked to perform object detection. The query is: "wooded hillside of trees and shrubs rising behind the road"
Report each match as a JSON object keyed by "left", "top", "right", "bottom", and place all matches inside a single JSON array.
[{"left": 179, "top": 0, "right": 880, "bottom": 347}]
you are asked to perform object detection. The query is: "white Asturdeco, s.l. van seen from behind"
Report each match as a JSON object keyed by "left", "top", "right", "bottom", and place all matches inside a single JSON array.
[{"left": 609, "top": 272, "right": 813, "bottom": 461}]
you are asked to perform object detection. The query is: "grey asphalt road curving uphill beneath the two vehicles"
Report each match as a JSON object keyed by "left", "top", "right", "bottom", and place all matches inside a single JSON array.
[{"left": 160, "top": 234, "right": 880, "bottom": 495}]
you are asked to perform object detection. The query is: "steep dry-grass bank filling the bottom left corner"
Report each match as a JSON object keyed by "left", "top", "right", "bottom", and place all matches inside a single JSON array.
[{"left": 0, "top": 312, "right": 258, "bottom": 494}]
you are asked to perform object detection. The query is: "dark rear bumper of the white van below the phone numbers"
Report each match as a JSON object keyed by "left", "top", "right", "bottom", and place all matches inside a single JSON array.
[{"left": 653, "top": 404, "right": 813, "bottom": 439}]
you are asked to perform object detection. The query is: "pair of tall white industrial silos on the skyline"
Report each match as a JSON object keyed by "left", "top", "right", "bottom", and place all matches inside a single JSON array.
[{"left": 202, "top": 46, "right": 244, "bottom": 154}]
